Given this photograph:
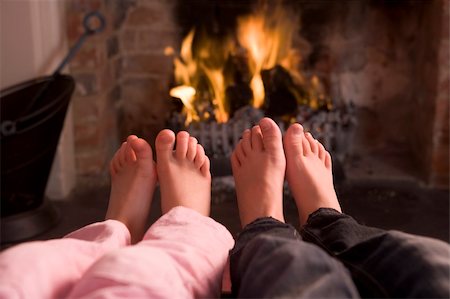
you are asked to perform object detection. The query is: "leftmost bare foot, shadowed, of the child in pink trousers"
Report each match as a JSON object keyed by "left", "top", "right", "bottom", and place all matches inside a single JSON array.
[{"left": 105, "top": 135, "right": 156, "bottom": 244}]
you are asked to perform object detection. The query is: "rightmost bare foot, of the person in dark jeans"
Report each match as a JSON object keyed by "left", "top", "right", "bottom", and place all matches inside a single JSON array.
[{"left": 284, "top": 124, "right": 341, "bottom": 225}]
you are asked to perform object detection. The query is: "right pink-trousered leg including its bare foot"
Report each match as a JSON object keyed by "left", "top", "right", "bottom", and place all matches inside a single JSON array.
[{"left": 71, "top": 130, "right": 233, "bottom": 298}]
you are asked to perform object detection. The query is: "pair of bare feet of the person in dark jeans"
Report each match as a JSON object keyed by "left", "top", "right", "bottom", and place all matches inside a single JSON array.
[{"left": 231, "top": 118, "right": 341, "bottom": 227}]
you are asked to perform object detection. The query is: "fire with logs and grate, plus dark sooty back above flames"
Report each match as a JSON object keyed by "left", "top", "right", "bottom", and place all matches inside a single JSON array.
[{"left": 166, "top": 1, "right": 354, "bottom": 169}]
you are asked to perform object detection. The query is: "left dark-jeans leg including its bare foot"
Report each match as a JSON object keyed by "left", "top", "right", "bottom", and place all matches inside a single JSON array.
[{"left": 230, "top": 118, "right": 358, "bottom": 298}]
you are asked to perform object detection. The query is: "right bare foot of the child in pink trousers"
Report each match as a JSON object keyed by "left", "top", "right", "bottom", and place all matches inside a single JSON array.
[{"left": 156, "top": 130, "right": 211, "bottom": 216}]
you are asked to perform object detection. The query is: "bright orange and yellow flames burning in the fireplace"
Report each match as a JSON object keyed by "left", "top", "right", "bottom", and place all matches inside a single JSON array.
[{"left": 166, "top": 5, "right": 326, "bottom": 125}]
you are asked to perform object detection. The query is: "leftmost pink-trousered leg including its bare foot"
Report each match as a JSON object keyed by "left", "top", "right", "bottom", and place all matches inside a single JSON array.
[{"left": 0, "top": 136, "right": 156, "bottom": 298}]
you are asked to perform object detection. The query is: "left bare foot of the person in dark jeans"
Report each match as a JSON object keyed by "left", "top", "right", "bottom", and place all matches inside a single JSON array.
[{"left": 231, "top": 118, "right": 286, "bottom": 227}]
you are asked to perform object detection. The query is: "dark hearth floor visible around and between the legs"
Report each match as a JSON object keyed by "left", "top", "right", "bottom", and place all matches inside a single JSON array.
[{"left": 3, "top": 182, "right": 449, "bottom": 248}]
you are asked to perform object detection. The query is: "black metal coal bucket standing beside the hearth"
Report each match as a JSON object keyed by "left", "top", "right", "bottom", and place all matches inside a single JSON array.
[{"left": 0, "top": 75, "right": 75, "bottom": 243}]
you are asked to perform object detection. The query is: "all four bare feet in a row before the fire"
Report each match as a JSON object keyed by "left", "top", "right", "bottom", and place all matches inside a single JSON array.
[{"left": 106, "top": 118, "right": 340, "bottom": 243}]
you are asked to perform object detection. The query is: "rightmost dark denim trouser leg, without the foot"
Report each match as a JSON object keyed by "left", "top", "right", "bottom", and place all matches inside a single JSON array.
[{"left": 301, "top": 209, "right": 450, "bottom": 298}]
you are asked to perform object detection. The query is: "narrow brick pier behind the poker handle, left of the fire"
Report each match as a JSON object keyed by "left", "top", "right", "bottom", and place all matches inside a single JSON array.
[{"left": 67, "top": 0, "right": 134, "bottom": 176}]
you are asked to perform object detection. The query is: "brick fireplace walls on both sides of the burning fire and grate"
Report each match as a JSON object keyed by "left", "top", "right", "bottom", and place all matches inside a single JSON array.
[{"left": 68, "top": 0, "right": 449, "bottom": 188}]
